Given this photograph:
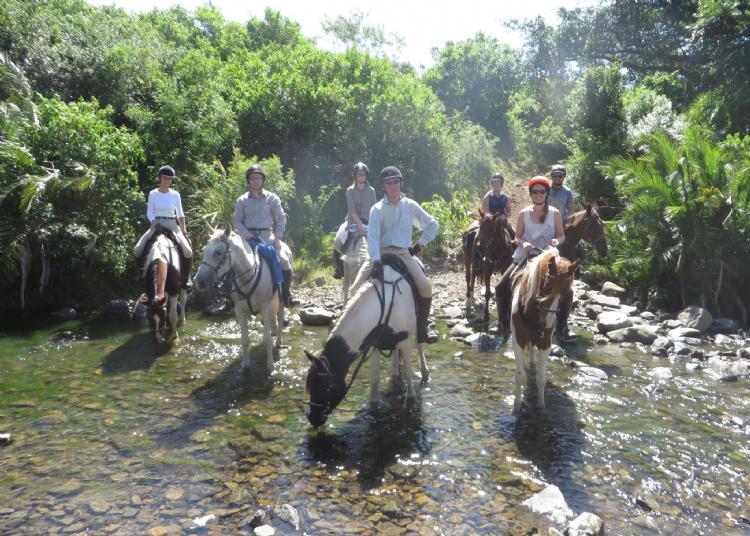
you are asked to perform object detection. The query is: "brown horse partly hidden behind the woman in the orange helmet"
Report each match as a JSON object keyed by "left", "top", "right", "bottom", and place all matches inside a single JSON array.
[{"left": 556, "top": 205, "right": 607, "bottom": 340}]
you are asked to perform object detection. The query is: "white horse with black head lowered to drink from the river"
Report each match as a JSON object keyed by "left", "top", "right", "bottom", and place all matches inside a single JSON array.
[{"left": 305, "top": 255, "right": 429, "bottom": 428}]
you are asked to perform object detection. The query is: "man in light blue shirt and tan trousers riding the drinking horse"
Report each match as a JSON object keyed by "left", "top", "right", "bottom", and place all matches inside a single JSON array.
[{"left": 352, "top": 166, "right": 440, "bottom": 343}]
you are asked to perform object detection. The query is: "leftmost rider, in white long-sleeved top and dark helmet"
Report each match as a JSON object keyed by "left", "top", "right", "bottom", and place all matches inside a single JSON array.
[{"left": 133, "top": 166, "right": 193, "bottom": 302}]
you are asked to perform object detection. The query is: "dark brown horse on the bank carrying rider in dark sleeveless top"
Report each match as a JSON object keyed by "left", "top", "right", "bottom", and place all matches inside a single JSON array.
[{"left": 462, "top": 211, "right": 513, "bottom": 322}]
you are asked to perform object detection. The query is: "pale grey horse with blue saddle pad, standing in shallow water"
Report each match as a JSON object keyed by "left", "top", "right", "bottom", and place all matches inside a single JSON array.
[{"left": 195, "top": 227, "right": 291, "bottom": 374}]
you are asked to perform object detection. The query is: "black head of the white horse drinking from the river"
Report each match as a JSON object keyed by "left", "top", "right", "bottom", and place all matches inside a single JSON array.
[{"left": 305, "top": 350, "right": 347, "bottom": 428}]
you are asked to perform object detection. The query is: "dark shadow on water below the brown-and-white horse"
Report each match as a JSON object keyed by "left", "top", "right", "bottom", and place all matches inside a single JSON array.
[{"left": 500, "top": 382, "right": 589, "bottom": 510}]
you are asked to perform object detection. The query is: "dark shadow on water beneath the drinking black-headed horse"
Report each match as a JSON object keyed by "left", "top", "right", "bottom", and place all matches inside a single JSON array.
[{"left": 304, "top": 387, "right": 430, "bottom": 489}]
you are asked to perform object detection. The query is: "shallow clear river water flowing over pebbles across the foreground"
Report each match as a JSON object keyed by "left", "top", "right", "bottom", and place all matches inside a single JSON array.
[{"left": 0, "top": 308, "right": 750, "bottom": 535}]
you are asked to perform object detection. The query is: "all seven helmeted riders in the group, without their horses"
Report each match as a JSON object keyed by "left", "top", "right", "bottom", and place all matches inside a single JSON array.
[{"left": 134, "top": 162, "right": 574, "bottom": 343}]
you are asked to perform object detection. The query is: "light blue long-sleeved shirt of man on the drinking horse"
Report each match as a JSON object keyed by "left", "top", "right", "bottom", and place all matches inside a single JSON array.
[{"left": 367, "top": 196, "right": 440, "bottom": 261}]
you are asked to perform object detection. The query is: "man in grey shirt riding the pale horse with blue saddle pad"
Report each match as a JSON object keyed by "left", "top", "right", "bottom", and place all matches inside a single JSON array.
[{"left": 234, "top": 164, "right": 294, "bottom": 307}]
